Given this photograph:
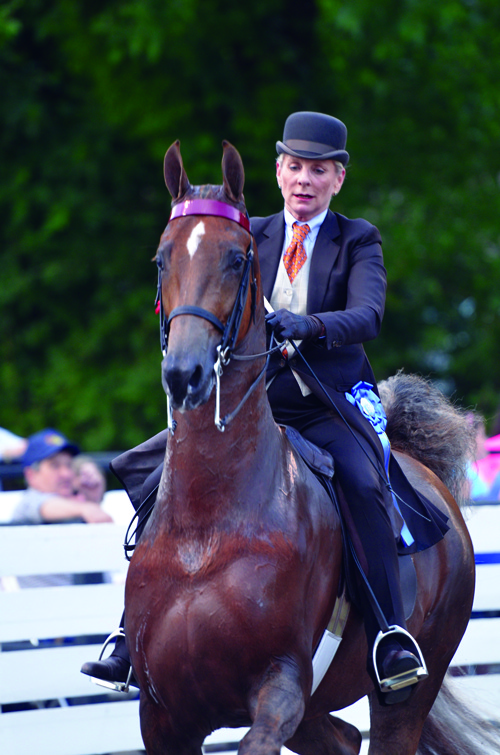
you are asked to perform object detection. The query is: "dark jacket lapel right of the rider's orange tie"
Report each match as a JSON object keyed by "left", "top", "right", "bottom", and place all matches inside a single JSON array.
[{"left": 307, "top": 210, "right": 340, "bottom": 314}]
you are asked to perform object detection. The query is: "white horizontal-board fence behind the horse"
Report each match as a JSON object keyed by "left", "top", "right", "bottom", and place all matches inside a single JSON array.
[{"left": 0, "top": 494, "right": 500, "bottom": 755}]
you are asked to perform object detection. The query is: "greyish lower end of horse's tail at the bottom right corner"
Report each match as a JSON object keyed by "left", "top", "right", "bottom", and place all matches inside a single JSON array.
[{"left": 416, "top": 681, "right": 500, "bottom": 755}]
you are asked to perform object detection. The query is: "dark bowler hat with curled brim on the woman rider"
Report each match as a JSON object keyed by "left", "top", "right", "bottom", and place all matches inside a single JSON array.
[{"left": 276, "top": 111, "right": 349, "bottom": 165}]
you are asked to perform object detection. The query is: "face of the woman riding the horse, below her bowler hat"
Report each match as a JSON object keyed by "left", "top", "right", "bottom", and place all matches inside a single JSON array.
[{"left": 276, "top": 154, "right": 345, "bottom": 222}]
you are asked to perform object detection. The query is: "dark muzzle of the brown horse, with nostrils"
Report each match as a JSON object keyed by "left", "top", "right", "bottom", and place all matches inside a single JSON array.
[{"left": 161, "top": 353, "right": 214, "bottom": 411}]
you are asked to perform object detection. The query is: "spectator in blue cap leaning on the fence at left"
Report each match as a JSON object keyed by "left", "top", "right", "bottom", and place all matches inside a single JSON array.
[{"left": 12, "top": 428, "right": 112, "bottom": 524}]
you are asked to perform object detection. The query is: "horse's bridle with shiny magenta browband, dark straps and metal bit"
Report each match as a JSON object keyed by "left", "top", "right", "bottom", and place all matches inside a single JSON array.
[{"left": 156, "top": 199, "right": 274, "bottom": 434}]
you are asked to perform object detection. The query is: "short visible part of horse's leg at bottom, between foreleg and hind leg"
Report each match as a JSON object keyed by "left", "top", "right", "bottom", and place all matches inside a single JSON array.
[{"left": 286, "top": 713, "right": 361, "bottom": 755}]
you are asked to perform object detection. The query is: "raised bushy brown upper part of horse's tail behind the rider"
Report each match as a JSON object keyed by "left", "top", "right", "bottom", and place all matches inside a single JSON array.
[{"left": 378, "top": 372, "right": 475, "bottom": 505}]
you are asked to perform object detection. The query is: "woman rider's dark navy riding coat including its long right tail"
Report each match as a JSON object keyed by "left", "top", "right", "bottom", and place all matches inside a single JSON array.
[{"left": 251, "top": 210, "right": 448, "bottom": 550}]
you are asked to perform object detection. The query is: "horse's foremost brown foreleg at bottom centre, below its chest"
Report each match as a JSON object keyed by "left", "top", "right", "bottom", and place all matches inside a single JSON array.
[{"left": 238, "top": 658, "right": 305, "bottom": 755}]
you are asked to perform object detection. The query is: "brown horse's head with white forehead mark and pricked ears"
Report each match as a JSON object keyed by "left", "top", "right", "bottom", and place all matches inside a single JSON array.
[{"left": 156, "top": 141, "right": 255, "bottom": 411}]
